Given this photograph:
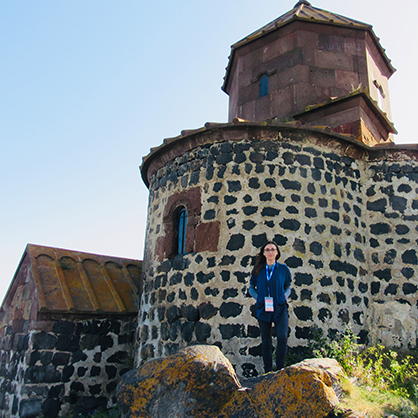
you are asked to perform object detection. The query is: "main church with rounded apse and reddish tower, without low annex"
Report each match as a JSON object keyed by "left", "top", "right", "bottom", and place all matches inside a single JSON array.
[{"left": 137, "top": 1, "right": 418, "bottom": 376}]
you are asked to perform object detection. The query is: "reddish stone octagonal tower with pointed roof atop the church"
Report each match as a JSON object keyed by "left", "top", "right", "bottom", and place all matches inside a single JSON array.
[{"left": 222, "top": 0, "right": 396, "bottom": 145}]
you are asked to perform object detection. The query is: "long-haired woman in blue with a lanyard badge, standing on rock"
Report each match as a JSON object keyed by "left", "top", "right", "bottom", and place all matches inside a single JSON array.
[{"left": 249, "top": 241, "right": 291, "bottom": 373}]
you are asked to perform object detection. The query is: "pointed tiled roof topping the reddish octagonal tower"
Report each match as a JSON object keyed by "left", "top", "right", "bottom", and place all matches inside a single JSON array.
[{"left": 222, "top": 0, "right": 396, "bottom": 92}]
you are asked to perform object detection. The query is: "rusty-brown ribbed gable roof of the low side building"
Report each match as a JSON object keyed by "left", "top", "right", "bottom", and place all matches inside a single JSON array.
[{"left": 3, "top": 244, "right": 142, "bottom": 314}]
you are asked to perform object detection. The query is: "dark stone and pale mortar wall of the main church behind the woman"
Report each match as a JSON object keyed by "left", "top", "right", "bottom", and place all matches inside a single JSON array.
[{"left": 137, "top": 123, "right": 418, "bottom": 376}]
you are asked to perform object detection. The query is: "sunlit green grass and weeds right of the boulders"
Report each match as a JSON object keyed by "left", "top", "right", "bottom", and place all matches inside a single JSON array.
[{"left": 305, "top": 327, "right": 418, "bottom": 418}]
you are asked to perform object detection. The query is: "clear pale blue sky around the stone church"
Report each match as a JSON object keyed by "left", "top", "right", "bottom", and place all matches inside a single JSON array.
[{"left": 0, "top": 0, "right": 418, "bottom": 301}]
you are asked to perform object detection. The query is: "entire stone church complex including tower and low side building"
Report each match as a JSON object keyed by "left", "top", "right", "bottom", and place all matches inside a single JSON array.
[{"left": 0, "top": 0, "right": 418, "bottom": 417}]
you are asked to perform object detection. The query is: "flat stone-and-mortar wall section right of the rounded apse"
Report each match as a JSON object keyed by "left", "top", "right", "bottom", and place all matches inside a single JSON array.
[{"left": 364, "top": 156, "right": 418, "bottom": 347}]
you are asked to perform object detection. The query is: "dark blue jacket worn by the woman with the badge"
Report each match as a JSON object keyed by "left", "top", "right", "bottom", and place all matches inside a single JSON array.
[{"left": 249, "top": 261, "right": 292, "bottom": 322}]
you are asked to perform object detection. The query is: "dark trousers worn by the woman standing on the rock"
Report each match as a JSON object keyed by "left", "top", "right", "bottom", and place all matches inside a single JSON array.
[{"left": 258, "top": 308, "right": 289, "bottom": 373}]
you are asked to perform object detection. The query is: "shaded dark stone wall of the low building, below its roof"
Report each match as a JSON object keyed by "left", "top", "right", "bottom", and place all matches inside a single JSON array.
[{"left": 0, "top": 316, "right": 136, "bottom": 418}]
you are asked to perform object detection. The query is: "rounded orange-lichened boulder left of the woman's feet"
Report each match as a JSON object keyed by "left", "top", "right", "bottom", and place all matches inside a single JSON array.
[{"left": 117, "top": 345, "right": 240, "bottom": 418}]
